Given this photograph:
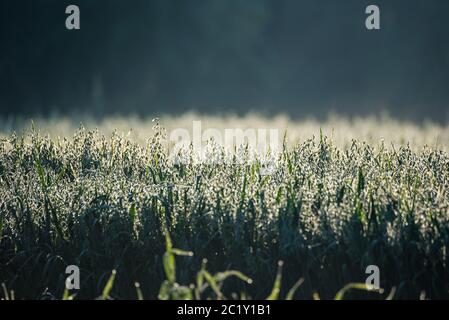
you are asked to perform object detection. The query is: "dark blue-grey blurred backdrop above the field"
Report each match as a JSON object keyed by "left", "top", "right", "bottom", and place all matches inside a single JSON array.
[{"left": 0, "top": 0, "right": 449, "bottom": 122}]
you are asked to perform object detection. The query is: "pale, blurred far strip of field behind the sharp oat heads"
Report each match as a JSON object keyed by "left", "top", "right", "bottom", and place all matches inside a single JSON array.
[{"left": 0, "top": 112, "right": 449, "bottom": 151}]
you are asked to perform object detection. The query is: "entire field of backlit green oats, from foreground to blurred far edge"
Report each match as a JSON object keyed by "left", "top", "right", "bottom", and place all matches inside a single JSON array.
[{"left": 0, "top": 115, "right": 449, "bottom": 299}]
